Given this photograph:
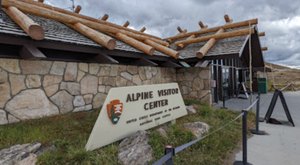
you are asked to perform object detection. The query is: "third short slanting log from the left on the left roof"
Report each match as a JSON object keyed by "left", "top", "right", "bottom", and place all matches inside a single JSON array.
[{"left": 114, "top": 33, "right": 155, "bottom": 55}]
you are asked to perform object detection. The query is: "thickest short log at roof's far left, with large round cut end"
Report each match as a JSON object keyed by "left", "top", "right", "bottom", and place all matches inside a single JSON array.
[{"left": 4, "top": 6, "right": 45, "bottom": 40}]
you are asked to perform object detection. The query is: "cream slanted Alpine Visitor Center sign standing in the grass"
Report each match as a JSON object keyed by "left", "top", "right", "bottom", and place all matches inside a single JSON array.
[{"left": 85, "top": 83, "right": 187, "bottom": 150}]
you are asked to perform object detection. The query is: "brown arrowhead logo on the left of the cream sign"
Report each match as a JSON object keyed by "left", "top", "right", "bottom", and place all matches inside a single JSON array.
[{"left": 106, "top": 100, "right": 123, "bottom": 124}]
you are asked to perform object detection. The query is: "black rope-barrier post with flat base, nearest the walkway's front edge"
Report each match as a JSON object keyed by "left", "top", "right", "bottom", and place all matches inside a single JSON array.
[{"left": 233, "top": 110, "right": 251, "bottom": 165}]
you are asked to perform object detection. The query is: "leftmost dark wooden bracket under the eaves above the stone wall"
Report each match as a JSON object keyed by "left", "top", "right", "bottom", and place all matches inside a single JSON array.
[{"left": 19, "top": 45, "right": 47, "bottom": 59}]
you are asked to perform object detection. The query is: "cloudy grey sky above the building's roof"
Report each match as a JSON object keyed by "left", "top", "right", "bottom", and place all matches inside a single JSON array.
[{"left": 46, "top": 0, "right": 300, "bottom": 68}]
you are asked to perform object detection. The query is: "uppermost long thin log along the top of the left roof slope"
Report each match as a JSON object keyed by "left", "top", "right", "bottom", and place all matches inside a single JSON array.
[{"left": 12, "top": 0, "right": 161, "bottom": 39}]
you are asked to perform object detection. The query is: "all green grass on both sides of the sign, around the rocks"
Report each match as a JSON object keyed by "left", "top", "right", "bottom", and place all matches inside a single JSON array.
[{"left": 0, "top": 100, "right": 254, "bottom": 165}]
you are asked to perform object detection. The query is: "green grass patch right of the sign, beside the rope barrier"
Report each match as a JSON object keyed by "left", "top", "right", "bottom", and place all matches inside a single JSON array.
[{"left": 150, "top": 100, "right": 254, "bottom": 165}]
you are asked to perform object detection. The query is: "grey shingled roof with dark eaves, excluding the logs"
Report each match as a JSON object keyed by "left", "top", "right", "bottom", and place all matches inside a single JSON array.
[{"left": 0, "top": 0, "right": 263, "bottom": 67}]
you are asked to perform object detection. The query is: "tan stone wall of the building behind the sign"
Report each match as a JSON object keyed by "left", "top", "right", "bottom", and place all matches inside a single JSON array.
[{"left": 0, "top": 59, "right": 210, "bottom": 125}]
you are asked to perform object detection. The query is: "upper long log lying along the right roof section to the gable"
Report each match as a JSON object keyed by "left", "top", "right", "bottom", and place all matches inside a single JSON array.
[{"left": 165, "top": 19, "right": 258, "bottom": 42}]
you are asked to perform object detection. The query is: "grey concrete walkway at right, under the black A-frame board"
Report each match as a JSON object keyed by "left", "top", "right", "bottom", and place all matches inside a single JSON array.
[{"left": 216, "top": 91, "right": 300, "bottom": 165}]
